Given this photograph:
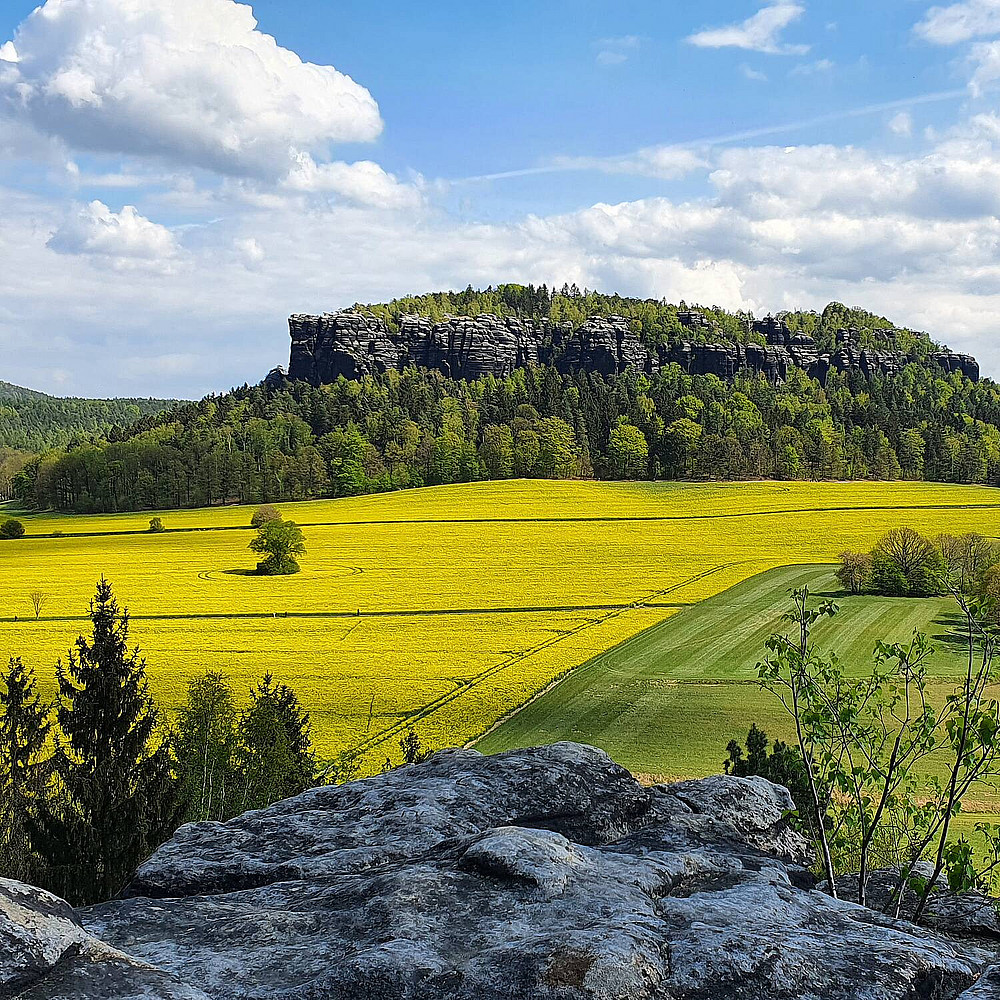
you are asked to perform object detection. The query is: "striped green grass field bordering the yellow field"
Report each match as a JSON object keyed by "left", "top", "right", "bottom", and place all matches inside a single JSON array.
[{"left": 477, "top": 566, "right": 992, "bottom": 806}]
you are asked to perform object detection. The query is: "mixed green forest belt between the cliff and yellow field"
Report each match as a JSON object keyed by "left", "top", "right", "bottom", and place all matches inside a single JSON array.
[{"left": 13, "top": 352, "right": 1000, "bottom": 512}]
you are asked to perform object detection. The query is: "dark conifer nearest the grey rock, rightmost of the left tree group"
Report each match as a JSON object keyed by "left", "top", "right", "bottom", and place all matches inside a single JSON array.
[{"left": 239, "top": 673, "right": 316, "bottom": 809}]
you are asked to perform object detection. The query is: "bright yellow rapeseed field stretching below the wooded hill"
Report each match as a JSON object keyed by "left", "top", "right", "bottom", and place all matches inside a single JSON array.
[{"left": 0, "top": 481, "right": 1000, "bottom": 768}]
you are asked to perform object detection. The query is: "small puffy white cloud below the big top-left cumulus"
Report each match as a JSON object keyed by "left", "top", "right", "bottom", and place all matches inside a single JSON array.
[{"left": 46, "top": 201, "right": 179, "bottom": 266}]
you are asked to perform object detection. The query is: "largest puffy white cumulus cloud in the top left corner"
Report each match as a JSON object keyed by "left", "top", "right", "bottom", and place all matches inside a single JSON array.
[{"left": 0, "top": 0, "right": 382, "bottom": 179}]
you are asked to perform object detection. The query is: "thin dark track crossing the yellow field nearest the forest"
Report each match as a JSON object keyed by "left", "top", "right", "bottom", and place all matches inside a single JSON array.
[{"left": 17, "top": 503, "right": 1000, "bottom": 540}]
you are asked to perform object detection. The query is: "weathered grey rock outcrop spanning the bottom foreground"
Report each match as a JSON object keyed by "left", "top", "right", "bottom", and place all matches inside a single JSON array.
[{"left": 0, "top": 743, "right": 1000, "bottom": 1000}]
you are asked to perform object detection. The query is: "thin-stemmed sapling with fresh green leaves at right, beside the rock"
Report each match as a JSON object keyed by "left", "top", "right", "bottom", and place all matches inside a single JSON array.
[{"left": 758, "top": 578, "right": 1000, "bottom": 919}]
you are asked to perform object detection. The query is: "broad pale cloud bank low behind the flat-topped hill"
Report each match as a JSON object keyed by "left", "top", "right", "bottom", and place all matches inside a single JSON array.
[{"left": 7, "top": 127, "right": 1000, "bottom": 396}]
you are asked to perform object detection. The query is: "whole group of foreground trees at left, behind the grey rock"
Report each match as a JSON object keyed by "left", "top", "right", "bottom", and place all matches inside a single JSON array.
[{"left": 0, "top": 579, "right": 425, "bottom": 904}]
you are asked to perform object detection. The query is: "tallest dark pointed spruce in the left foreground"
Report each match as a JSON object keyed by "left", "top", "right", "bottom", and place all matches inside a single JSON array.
[{"left": 37, "top": 577, "right": 178, "bottom": 903}]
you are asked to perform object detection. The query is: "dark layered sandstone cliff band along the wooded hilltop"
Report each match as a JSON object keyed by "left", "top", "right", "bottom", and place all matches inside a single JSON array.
[{"left": 288, "top": 311, "right": 979, "bottom": 385}]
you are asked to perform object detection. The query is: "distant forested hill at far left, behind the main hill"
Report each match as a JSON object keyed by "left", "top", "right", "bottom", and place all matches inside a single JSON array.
[{"left": 0, "top": 382, "right": 177, "bottom": 452}]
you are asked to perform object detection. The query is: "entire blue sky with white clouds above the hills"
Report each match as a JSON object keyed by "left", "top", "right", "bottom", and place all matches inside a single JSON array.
[{"left": 0, "top": 0, "right": 1000, "bottom": 396}]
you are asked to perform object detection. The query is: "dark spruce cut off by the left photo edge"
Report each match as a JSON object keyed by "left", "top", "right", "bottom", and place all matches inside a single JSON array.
[{"left": 0, "top": 657, "right": 52, "bottom": 882}]
